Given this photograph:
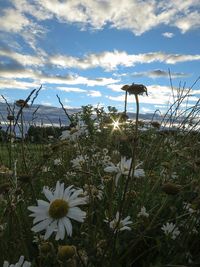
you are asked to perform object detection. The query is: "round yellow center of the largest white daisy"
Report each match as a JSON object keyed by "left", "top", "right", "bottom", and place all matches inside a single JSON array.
[{"left": 49, "top": 199, "right": 69, "bottom": 219}]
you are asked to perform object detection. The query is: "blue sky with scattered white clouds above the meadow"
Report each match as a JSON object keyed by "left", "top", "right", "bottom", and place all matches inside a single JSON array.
[{"left": 0, "top": 0, "right": 200, "bottom": 113}]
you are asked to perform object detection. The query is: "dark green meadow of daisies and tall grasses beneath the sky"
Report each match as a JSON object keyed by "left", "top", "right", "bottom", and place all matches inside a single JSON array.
[{"left": 0, "top": 83, "right": 200, "bottom": 267}]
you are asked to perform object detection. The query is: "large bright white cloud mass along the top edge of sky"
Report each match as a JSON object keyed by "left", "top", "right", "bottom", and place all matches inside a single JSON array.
[{"left": 33, "top": 0, "right": 200, "bottom": 35}]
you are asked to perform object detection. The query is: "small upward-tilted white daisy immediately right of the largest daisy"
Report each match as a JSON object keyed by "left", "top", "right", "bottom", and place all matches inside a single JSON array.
[{"left": 104, "top": 212, "right": 132, "bottom": 232}]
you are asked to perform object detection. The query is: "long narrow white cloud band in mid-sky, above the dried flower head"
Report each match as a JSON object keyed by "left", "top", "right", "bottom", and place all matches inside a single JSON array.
[{"left": 49, "top": 50, "right": 200, "bottom": 71}]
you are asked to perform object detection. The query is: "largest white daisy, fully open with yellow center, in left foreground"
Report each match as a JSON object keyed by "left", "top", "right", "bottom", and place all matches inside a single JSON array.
[{"left": 28, "top": 181, "right": 88, "bottom": 240}]
